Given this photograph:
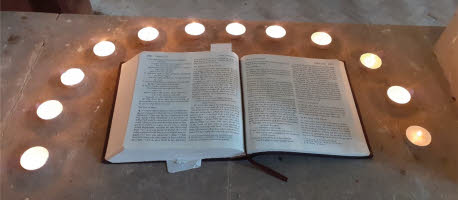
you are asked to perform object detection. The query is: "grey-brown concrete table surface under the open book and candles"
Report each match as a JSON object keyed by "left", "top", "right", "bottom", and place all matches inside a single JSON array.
[{"left": 0, "top": 12, "right": 458, "bottom": 200}]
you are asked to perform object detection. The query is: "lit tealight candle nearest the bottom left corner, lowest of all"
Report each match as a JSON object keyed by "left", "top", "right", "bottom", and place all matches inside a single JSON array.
[{"left": 19, "top": 146, "right": 49, "bottom": 170}]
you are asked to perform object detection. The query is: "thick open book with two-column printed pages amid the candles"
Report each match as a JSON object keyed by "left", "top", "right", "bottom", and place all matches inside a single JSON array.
[{"left": 105, "top": 52, "right": 370, "bottom": 163}]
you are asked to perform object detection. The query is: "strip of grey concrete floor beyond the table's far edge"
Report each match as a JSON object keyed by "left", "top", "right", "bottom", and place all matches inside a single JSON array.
[{"left": 91, "top": 0, "right": 458, "bottom": 26}]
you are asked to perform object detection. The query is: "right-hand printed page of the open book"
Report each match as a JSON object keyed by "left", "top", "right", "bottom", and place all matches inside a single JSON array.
[{"left": 241, "top": 55, "right": 370, "bottom": 156}]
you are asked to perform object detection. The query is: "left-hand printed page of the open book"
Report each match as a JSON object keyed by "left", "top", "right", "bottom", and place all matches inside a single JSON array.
[{"left": 124, "top": 52, "right": 244, "bottom": 160}]
